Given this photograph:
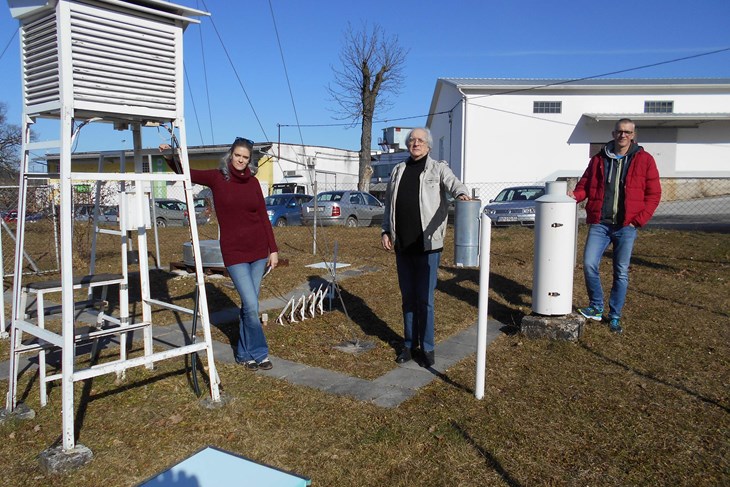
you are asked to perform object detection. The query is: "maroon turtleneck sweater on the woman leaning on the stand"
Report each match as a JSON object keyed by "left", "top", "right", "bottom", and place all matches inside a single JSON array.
[{"left": 190, "top": 164, "right": 279, "bottom": 267}]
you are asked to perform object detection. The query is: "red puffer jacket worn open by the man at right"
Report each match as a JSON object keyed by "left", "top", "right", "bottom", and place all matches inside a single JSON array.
[{"left": 573, "top": 147, "right": 662, "bottom": 227}]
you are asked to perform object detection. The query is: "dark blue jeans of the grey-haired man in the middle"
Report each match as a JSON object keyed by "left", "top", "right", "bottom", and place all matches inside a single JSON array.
[{"left": 395, "top": 252, "right": 441, "bottom": 352}]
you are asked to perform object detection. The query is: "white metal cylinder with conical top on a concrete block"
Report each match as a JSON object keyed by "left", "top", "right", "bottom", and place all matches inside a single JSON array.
[{"left": 532, "top": 181, "right": 577, "bottom": 315}]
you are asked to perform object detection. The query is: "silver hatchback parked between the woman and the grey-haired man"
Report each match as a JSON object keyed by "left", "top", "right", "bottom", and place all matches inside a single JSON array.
[{"left": 302, "top": 191, "right": 384, "bottom": 227}]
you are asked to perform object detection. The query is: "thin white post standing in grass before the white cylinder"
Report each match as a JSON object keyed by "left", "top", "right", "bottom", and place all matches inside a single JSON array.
[{"left": 474, "top": 211, "right": 492, "bottom": 399}]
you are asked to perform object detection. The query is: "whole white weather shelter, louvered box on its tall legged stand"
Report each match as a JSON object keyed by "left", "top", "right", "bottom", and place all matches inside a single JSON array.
[{"left": 6, "top": 0, "right": 220, "bottom": 451}]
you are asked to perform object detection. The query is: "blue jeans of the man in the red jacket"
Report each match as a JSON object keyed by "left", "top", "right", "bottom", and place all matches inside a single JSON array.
[{"left": 583, "top": 223, "right": 637, "bottom": 319}]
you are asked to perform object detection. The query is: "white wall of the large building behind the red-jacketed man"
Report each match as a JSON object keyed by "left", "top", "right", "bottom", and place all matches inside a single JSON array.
[{"left": 430, "top": 84, "right": 730, "bottom": 184}]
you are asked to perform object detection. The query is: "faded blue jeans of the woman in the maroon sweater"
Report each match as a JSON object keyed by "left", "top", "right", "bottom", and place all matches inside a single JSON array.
[{"left": 226, "top": 259, "right": 269, "bottom": 362}]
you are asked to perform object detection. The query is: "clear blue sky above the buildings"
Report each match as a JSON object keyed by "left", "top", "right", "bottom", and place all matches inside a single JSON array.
[{"left": 0, "top": 0, "right": 730, "bottom": 151}]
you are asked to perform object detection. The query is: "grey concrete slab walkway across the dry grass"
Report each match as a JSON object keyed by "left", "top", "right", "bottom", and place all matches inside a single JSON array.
[{"left": 0, "top": 278, "right": 503, "bottom": 408}]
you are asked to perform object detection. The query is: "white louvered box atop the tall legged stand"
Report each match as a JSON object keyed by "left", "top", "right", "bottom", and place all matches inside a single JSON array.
[{"left": 23, "top": 2, "right": 181, "bottom": 119}]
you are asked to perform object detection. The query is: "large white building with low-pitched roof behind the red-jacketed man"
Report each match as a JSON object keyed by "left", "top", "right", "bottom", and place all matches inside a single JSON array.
[{"left": 427, "top": 78, "right": 730, "bottom": 196}]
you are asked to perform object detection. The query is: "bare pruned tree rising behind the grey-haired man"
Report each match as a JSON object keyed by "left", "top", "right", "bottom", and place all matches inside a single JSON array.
[{"left": 328, "top": 24, "right": 408, "bottom": 191}]
